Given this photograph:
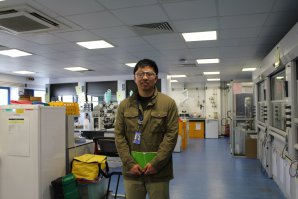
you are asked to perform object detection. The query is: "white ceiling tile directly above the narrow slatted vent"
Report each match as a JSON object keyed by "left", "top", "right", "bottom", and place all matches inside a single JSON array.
[{"left": 112, "top": 5, "right": 168, "bottom": 25}]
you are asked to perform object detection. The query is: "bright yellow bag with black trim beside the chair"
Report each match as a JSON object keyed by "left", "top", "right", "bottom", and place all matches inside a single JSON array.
[{"left": 71, "top": 154, "right": 108, "bottom": 180}]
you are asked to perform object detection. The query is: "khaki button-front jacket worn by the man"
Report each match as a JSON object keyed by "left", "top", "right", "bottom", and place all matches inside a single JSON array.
[{"left": 115, "top": 89, "right": 178, "bottom": 181}]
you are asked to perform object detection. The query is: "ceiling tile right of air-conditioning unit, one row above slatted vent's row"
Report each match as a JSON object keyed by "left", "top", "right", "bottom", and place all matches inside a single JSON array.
[{"left": 67, "top": 12, "right": 122, "bottom": 29}]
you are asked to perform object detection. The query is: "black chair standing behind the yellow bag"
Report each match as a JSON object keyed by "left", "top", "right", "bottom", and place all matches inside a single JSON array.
[{"left": 93, "top": 137, "right": 122, "bottom": 199}]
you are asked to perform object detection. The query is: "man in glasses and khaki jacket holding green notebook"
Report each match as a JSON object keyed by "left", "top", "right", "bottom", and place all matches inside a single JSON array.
[{"left": 115, "top": 59, "right": 178, "bottom": 199}]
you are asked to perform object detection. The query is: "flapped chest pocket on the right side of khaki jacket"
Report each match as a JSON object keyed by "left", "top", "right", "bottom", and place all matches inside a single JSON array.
[{"left": 151, "top": 111, "right": 167, "bottom": 133}]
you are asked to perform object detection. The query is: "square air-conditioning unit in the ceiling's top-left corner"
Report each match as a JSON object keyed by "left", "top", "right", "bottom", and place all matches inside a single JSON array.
[{"left": 0, "top": 6, "right": 59, "bottom": 34}]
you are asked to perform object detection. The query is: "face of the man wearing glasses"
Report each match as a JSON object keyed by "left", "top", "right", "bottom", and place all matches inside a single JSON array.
[{"left": 134, "top": 66, "right": 157, "bottom": 92}]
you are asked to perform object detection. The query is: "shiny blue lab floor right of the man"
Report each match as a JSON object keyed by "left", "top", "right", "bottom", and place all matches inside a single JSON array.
[{"left": 111, "top": 138, "right": 285, "bottom": 199}]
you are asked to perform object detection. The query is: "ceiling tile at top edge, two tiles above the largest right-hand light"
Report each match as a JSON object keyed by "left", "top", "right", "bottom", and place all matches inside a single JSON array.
[{"left": 163, "top": 0, "right": 217, "bottom": 20}]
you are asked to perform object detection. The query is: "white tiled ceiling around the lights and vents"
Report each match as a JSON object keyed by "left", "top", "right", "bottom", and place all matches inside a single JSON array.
[{"left": 0, "top": 0, "right": 298, "bottom": 83}]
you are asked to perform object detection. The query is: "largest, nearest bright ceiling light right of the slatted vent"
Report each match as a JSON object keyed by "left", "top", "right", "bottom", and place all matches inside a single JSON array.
[{"left": 182, "top": 31, "right": 217, "bottom": 42}]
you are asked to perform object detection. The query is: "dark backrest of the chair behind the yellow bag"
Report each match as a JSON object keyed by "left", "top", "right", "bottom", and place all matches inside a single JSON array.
[{"left": 93, "top": 137, "right": 119, "bottom": 157}]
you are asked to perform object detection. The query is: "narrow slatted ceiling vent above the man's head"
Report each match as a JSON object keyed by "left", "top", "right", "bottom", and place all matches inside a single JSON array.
[{"left": 132, "top": 22, "right": 173, "bottom": 36}]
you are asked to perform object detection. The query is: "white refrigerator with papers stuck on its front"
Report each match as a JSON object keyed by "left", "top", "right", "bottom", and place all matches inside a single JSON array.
[{"left": 0, "top": 105, "right": 66, "bottom": 199}]
